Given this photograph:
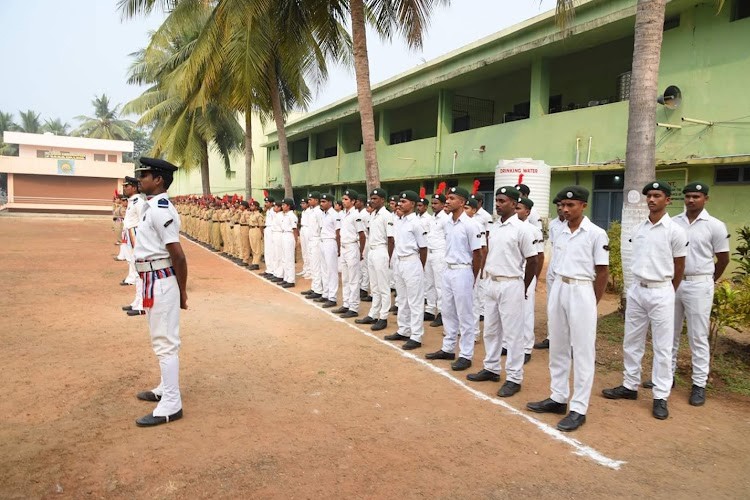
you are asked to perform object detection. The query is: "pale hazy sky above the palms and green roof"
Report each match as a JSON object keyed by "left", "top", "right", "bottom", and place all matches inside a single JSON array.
[{"left": 0, "top": 0, "right": 555, "bottom": 128}]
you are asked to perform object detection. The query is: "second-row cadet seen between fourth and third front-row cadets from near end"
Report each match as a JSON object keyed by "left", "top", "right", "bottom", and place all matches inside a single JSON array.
[{"left": 424, "top": 194, "right": 450, "bottom": 326}]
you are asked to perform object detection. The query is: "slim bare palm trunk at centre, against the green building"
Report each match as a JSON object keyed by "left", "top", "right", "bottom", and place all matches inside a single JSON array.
[{"left": 349, "top": 0, "right": 382, "bottom": 193}]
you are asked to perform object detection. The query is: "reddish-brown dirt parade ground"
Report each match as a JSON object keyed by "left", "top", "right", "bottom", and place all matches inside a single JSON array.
[{"left": 0, "top": 216, "right": 750, "bottom": 499}]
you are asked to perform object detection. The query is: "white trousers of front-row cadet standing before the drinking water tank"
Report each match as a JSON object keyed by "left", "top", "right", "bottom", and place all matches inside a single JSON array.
[{"left": 484, "top": 278, "right": 524, "bottom": 384}]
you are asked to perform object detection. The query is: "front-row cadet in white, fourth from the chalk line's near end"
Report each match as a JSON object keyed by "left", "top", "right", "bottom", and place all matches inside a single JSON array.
[{"left": 385, "top": 191, "right": 427, "bottom": 351}]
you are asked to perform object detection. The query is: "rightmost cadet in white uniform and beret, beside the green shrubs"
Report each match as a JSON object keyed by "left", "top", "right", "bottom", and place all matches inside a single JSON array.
[{"left": 672, "top": 182, "right": 729, "bottom": 406}]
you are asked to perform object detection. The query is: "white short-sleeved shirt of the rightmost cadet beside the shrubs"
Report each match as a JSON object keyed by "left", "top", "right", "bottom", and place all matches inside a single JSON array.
[{"left": 672, "top": 209, "right": 730, "bottom": 276}]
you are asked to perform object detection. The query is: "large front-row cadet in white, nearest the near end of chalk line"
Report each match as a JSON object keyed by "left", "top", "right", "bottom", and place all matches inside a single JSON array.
[{"left": 526, "top": 186, "right": 609, "bottom": 432}]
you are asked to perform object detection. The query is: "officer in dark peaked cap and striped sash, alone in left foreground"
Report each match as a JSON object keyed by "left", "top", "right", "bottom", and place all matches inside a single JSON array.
[{"left": 135, "top": 157, "right": 188, "bottom": 427}]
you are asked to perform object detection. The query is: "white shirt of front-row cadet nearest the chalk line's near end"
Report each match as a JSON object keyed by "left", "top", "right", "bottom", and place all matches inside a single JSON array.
[{"left": 552, "top": 217, "right": 609, "bottom": 281}]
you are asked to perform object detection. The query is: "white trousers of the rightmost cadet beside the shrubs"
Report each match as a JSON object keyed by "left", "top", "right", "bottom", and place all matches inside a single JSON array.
[{"left": 672, "top": 277, "right": 714, "bottom": 387}]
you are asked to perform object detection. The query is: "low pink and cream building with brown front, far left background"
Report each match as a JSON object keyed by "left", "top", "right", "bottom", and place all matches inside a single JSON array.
[{"left": 0, "top": 132, "right": 135, "bottom": 213}]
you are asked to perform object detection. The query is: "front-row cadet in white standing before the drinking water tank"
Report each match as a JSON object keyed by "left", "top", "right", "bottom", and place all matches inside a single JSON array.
[{"left": 467, "top": 186, "right": 537, "bottom": 397}]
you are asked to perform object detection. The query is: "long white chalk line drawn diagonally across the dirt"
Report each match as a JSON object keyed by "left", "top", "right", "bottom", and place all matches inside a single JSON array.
[{"left": 179, "top": 234, "right": 627, "bottom": 470}]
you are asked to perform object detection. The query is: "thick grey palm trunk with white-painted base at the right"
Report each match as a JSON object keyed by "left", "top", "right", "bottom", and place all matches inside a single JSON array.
[{"left": 620, "top": 0, "right": 666, "bottom": 293}]
